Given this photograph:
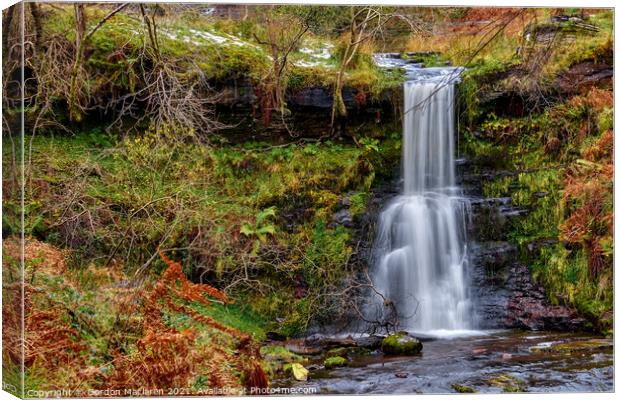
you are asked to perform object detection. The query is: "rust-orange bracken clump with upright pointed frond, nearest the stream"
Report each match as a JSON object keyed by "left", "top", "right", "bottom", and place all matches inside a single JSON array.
[{"left": 109, "top": 252, "right": 268, "bottom": 389}]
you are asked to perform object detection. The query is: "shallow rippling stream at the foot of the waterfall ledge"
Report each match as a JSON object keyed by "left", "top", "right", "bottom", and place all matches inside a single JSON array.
[{"left": 273, "top": 330, "right": 614, "bottom": 394}]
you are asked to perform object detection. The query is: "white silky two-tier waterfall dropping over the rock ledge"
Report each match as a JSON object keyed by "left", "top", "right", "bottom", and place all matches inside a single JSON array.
[{"left": 373, "top": 75, "right": 473, "bottom": 333}]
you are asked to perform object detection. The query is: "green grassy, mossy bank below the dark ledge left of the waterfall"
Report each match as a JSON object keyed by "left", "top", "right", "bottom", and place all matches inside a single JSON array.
[{"left": 4, "top": 126, "right": 399, "bottom": 337}]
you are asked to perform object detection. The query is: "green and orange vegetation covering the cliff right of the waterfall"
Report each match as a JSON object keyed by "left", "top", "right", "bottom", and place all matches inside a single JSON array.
[{"left": 461, "top": 12, "right": 613, "bottom": 332}]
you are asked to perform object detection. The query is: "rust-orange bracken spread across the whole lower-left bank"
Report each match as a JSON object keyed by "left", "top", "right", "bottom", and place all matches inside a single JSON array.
[{"left": 2, "top": 238, "right": 268, "bottom": 395}]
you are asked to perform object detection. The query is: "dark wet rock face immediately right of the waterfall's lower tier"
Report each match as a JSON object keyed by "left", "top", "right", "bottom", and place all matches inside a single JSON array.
[{"left": 460, "top": 163, "right": 585, "bottom": 331}]
